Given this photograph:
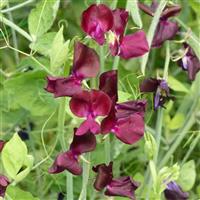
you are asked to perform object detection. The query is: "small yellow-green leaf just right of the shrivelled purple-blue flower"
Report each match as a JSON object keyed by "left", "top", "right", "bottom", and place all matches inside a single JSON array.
[{"left": 168, "top": 76, "right": 189, "bottom": 93}]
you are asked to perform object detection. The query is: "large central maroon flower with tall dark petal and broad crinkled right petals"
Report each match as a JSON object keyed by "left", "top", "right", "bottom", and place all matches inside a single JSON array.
[{"left": 99, "top": 70, "right": 146, "bottom": 144}]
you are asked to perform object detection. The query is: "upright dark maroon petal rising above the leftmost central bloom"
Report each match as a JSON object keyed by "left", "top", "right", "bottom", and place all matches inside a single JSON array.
[{"left": 73, "top": 42, "right": 100, "bottom": 80}]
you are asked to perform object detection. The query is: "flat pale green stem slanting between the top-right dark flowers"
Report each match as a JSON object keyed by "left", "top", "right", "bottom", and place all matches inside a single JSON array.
[{"left": 141, "top": 0, "right": 167, "bottom": 75}]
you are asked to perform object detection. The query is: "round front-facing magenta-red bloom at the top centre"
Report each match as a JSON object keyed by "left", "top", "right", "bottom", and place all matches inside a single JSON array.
[{"left": 81, "top": 4, "right": 113, "bottom": 45}]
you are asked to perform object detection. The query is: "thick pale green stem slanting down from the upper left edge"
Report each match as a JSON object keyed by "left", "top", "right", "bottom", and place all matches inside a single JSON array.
[{"left": 0, "top": 14, "right": 33, "bottom": 42}]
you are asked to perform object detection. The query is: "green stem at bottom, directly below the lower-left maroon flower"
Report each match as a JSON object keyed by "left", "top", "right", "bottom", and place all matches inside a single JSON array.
[{"left": 79, "top": 153, "right": 90, "bottom": 200}]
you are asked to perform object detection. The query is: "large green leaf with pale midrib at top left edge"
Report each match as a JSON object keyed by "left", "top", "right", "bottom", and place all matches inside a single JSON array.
[{"left": 28, "top": 0, "right": 60, "bottom": 41}]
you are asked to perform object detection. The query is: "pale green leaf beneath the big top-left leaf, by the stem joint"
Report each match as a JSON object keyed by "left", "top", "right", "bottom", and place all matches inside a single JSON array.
[{"left": 30, "top": 32, "right": 56, "bottom": 56}]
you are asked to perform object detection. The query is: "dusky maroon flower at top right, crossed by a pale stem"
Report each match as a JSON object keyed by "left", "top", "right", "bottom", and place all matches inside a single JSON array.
[{"left": 138, "top": 0, "right": 181, "bottom": 48}]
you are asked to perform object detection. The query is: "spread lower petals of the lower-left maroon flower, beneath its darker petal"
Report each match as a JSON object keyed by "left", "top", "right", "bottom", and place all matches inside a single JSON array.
[{"left": 49, "top": 151, "right": 82, "bottom": 175}]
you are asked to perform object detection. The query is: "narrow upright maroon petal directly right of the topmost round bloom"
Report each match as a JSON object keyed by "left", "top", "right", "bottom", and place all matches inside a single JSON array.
[{"left": 111, "top": 8, "right": 128, "bottom": 36}]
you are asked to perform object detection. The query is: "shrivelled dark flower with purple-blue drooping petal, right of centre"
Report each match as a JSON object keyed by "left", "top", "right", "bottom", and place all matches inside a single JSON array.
[{"left": 140, "top": 78, "right": 171, "bottom": 110}]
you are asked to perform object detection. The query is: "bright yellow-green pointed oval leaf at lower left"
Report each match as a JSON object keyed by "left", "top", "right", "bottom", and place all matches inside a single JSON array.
[{"left": 2, "top": 133, "right": 27, "bottom": 179}]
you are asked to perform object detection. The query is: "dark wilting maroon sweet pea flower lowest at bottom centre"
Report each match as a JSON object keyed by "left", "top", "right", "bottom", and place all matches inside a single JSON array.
[{"left": 92, "top": 162, "right": 139, "bottom": 200}]
